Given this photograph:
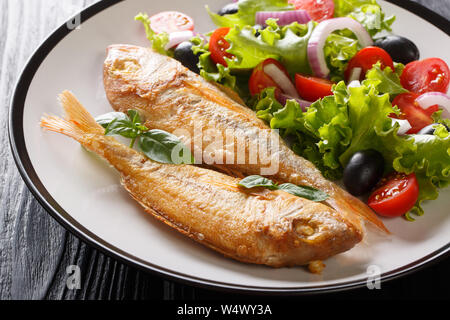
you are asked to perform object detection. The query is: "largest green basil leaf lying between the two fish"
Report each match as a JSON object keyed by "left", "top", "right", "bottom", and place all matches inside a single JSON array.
[{"left": 139, "top": 129, "right": 194, "bottom": 164}]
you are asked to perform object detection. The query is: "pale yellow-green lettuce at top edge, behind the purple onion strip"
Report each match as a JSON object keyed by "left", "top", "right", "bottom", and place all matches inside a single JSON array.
[{"left": 206, "top": 0, "right": 294, "bottom": 28}]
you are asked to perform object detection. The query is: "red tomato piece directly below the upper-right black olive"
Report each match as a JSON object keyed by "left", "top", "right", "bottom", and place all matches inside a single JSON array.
[{"left": 345, "top": 47, "right": 394, "bottom": 81}]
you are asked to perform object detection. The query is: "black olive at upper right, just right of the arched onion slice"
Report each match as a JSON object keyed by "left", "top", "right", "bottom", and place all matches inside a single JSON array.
[{"left": 375, "top": 35, "right": 420, "bottom": 64}]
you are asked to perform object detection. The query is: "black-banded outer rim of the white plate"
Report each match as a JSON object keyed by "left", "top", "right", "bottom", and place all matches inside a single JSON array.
[{"left": 8, "top": 0, "right": 450, "bottom": 295}]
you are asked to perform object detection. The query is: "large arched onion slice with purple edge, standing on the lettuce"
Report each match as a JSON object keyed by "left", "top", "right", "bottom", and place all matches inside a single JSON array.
[{"left": 308, "top": 17, "right": 373, "bottom": 78}]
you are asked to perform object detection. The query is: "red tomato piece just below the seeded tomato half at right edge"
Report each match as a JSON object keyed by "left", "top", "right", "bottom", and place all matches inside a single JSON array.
[{"left": 392, "top": 92, "right": 439, "bottom": 134}]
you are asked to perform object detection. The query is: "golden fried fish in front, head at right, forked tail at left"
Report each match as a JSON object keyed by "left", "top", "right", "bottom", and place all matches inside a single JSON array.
[{"left": 40, "top": 91, "right": 362, "bottom": 267}]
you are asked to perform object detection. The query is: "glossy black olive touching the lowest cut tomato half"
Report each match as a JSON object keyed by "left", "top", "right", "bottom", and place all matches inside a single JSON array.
[{"left": 344, "top": 149, "right": 384, "bottom": 196}]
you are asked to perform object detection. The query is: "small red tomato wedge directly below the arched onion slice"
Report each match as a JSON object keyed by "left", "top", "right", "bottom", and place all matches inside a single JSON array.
[{"left": 295, "top": 74, "right": 334, "bottom": 101}]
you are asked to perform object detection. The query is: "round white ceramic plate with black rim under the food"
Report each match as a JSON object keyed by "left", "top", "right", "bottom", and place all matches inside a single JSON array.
[{"left": 9, "top": 0, "right": 450, "bottom": 293}]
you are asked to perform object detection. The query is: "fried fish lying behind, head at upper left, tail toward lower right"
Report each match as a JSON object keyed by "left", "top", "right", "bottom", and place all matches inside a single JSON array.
[{"left": 103, "top": 45, "right": 389, "bottom": 232}]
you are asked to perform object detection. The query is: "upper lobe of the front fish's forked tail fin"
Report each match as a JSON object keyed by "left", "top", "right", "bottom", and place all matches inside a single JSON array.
[{"left": 59, "top": 90, "right": 105, "bottom": 134}]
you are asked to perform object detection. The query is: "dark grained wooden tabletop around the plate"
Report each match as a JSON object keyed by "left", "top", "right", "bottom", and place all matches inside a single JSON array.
[{"left": 0, "top": 0, "right": 450, "bottom": 300}]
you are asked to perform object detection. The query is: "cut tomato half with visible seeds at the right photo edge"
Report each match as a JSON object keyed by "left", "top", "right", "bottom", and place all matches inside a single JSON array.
[{"left": 400, "top": 58, "right": 450, "bottom": 94}]
